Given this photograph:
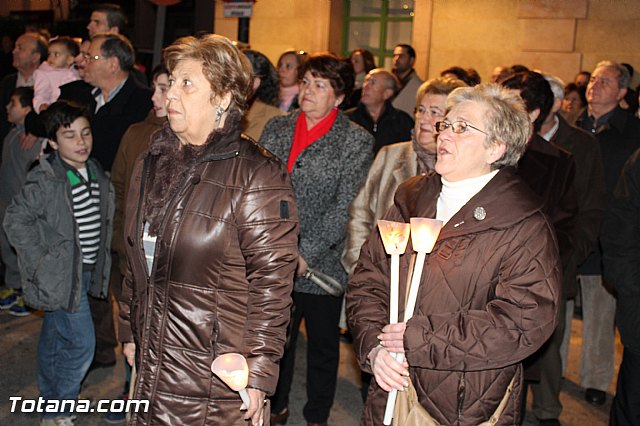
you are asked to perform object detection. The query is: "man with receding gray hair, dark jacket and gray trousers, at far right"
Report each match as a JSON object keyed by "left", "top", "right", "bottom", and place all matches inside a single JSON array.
[{"left": 577, "top": 61, "right": 640, "bottom": 405}]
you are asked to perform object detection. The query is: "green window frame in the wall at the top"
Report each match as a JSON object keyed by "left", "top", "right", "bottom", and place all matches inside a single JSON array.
[{"left": 342, "top": 0, "right": 414, "bottom": 68}]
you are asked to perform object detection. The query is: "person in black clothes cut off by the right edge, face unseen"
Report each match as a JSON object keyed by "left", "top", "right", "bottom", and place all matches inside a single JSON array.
[{"left": 602, "top": 150, "right": 640, "bottom": 426}]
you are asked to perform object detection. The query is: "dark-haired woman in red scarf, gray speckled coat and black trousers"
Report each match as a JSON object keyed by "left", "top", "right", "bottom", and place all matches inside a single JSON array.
[{"left": 260, "top": 53, "right": 373, "bottom": 425}]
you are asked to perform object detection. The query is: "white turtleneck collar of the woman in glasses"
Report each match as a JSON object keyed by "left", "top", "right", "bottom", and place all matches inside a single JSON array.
[{"left": 436, "top": 170, "right": 500, "bottom": 224}]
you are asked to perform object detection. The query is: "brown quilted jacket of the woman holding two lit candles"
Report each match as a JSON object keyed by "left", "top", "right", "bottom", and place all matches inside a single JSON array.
[{"left": 347, "top": 168, "right": 561, "bottom": 425}]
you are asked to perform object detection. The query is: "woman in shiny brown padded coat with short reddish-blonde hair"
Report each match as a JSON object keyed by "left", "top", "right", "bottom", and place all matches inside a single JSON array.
[{"left": 120, "top": 35, "right": 298, "bottom": 425}]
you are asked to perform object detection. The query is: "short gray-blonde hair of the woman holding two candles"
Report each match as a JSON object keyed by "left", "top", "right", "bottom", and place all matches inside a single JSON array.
[{"left": 447, "top": 83, "right": 532, "bottom": 170}]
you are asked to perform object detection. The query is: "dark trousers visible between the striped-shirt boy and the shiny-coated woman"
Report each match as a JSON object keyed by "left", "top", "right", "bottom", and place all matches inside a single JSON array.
[{"left": 89, "top": 252, "right": 122, "bottom": 364}]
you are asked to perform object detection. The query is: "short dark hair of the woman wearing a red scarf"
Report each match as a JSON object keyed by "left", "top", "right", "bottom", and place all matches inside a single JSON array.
[{"left": 298, "top": 52, "right": 355, "bottom": 98}]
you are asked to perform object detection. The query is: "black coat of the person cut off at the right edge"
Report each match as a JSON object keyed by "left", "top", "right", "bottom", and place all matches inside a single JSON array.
[{"left": 601, "top": 150, "right": 640, "bottom": 354}]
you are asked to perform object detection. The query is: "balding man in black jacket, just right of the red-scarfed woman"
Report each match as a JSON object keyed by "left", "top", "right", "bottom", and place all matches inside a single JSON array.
[{"left": 345, "top": 68, "right": 413, "bottom": 155}]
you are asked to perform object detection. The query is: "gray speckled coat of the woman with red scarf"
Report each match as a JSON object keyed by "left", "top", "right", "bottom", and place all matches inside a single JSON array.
[{"left": 260, "top": 110, "right": 373, "bottom": 295}]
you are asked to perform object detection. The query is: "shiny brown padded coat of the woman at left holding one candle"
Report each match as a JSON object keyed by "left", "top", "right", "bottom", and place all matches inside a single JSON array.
[{"left": 120, "top": 118, "right": 298, "bottom": 425}]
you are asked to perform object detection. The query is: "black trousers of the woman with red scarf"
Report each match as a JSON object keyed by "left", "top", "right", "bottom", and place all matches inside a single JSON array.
[{"left": 271, "top": 291, "right": 342, "bottom": 423}]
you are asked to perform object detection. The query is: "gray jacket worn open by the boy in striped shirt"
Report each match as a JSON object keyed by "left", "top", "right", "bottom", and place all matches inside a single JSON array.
[{"left": 4, "top": 153, "right": 115, "bottom": 312}]
